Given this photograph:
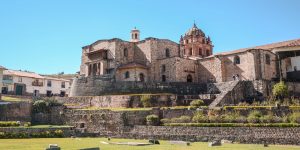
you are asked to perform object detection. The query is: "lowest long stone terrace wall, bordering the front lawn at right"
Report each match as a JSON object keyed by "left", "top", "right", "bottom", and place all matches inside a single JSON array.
[{"left": 120, "top": 126, "right": 300, "bottom": 145}]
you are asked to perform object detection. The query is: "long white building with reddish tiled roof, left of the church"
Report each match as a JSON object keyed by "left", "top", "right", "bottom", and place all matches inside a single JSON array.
[{"left": 2, "top": 70, "right": 70, "bottom": 97}]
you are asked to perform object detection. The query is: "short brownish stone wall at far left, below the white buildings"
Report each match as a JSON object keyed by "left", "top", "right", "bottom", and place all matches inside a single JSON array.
[{"left": 0, "top": 102, "right": 32, "bottom": 122}]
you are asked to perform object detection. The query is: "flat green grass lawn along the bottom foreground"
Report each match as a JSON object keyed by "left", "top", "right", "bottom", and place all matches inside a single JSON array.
[{"left": 0, "top": 138, "right": 300, "bottom": 150}]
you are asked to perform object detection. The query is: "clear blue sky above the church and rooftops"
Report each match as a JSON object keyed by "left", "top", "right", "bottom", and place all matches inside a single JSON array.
[{"left": 0, "top": 0, "right": 300, "bottom": 74}]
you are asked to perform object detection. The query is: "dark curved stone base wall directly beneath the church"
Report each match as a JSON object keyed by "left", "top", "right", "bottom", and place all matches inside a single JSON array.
[{"left": 70, "top": 77, "right": 207, "bottom": 97}]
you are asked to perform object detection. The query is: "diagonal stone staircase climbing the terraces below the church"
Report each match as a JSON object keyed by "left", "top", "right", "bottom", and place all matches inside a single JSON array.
[{"left": 209, "top": 81, "right": 241, "bottom": 108}]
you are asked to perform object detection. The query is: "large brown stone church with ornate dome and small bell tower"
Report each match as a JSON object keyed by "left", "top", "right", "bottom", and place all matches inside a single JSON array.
[{"left": 80, "top": 24, "right": 300, "bottom": 83}]
